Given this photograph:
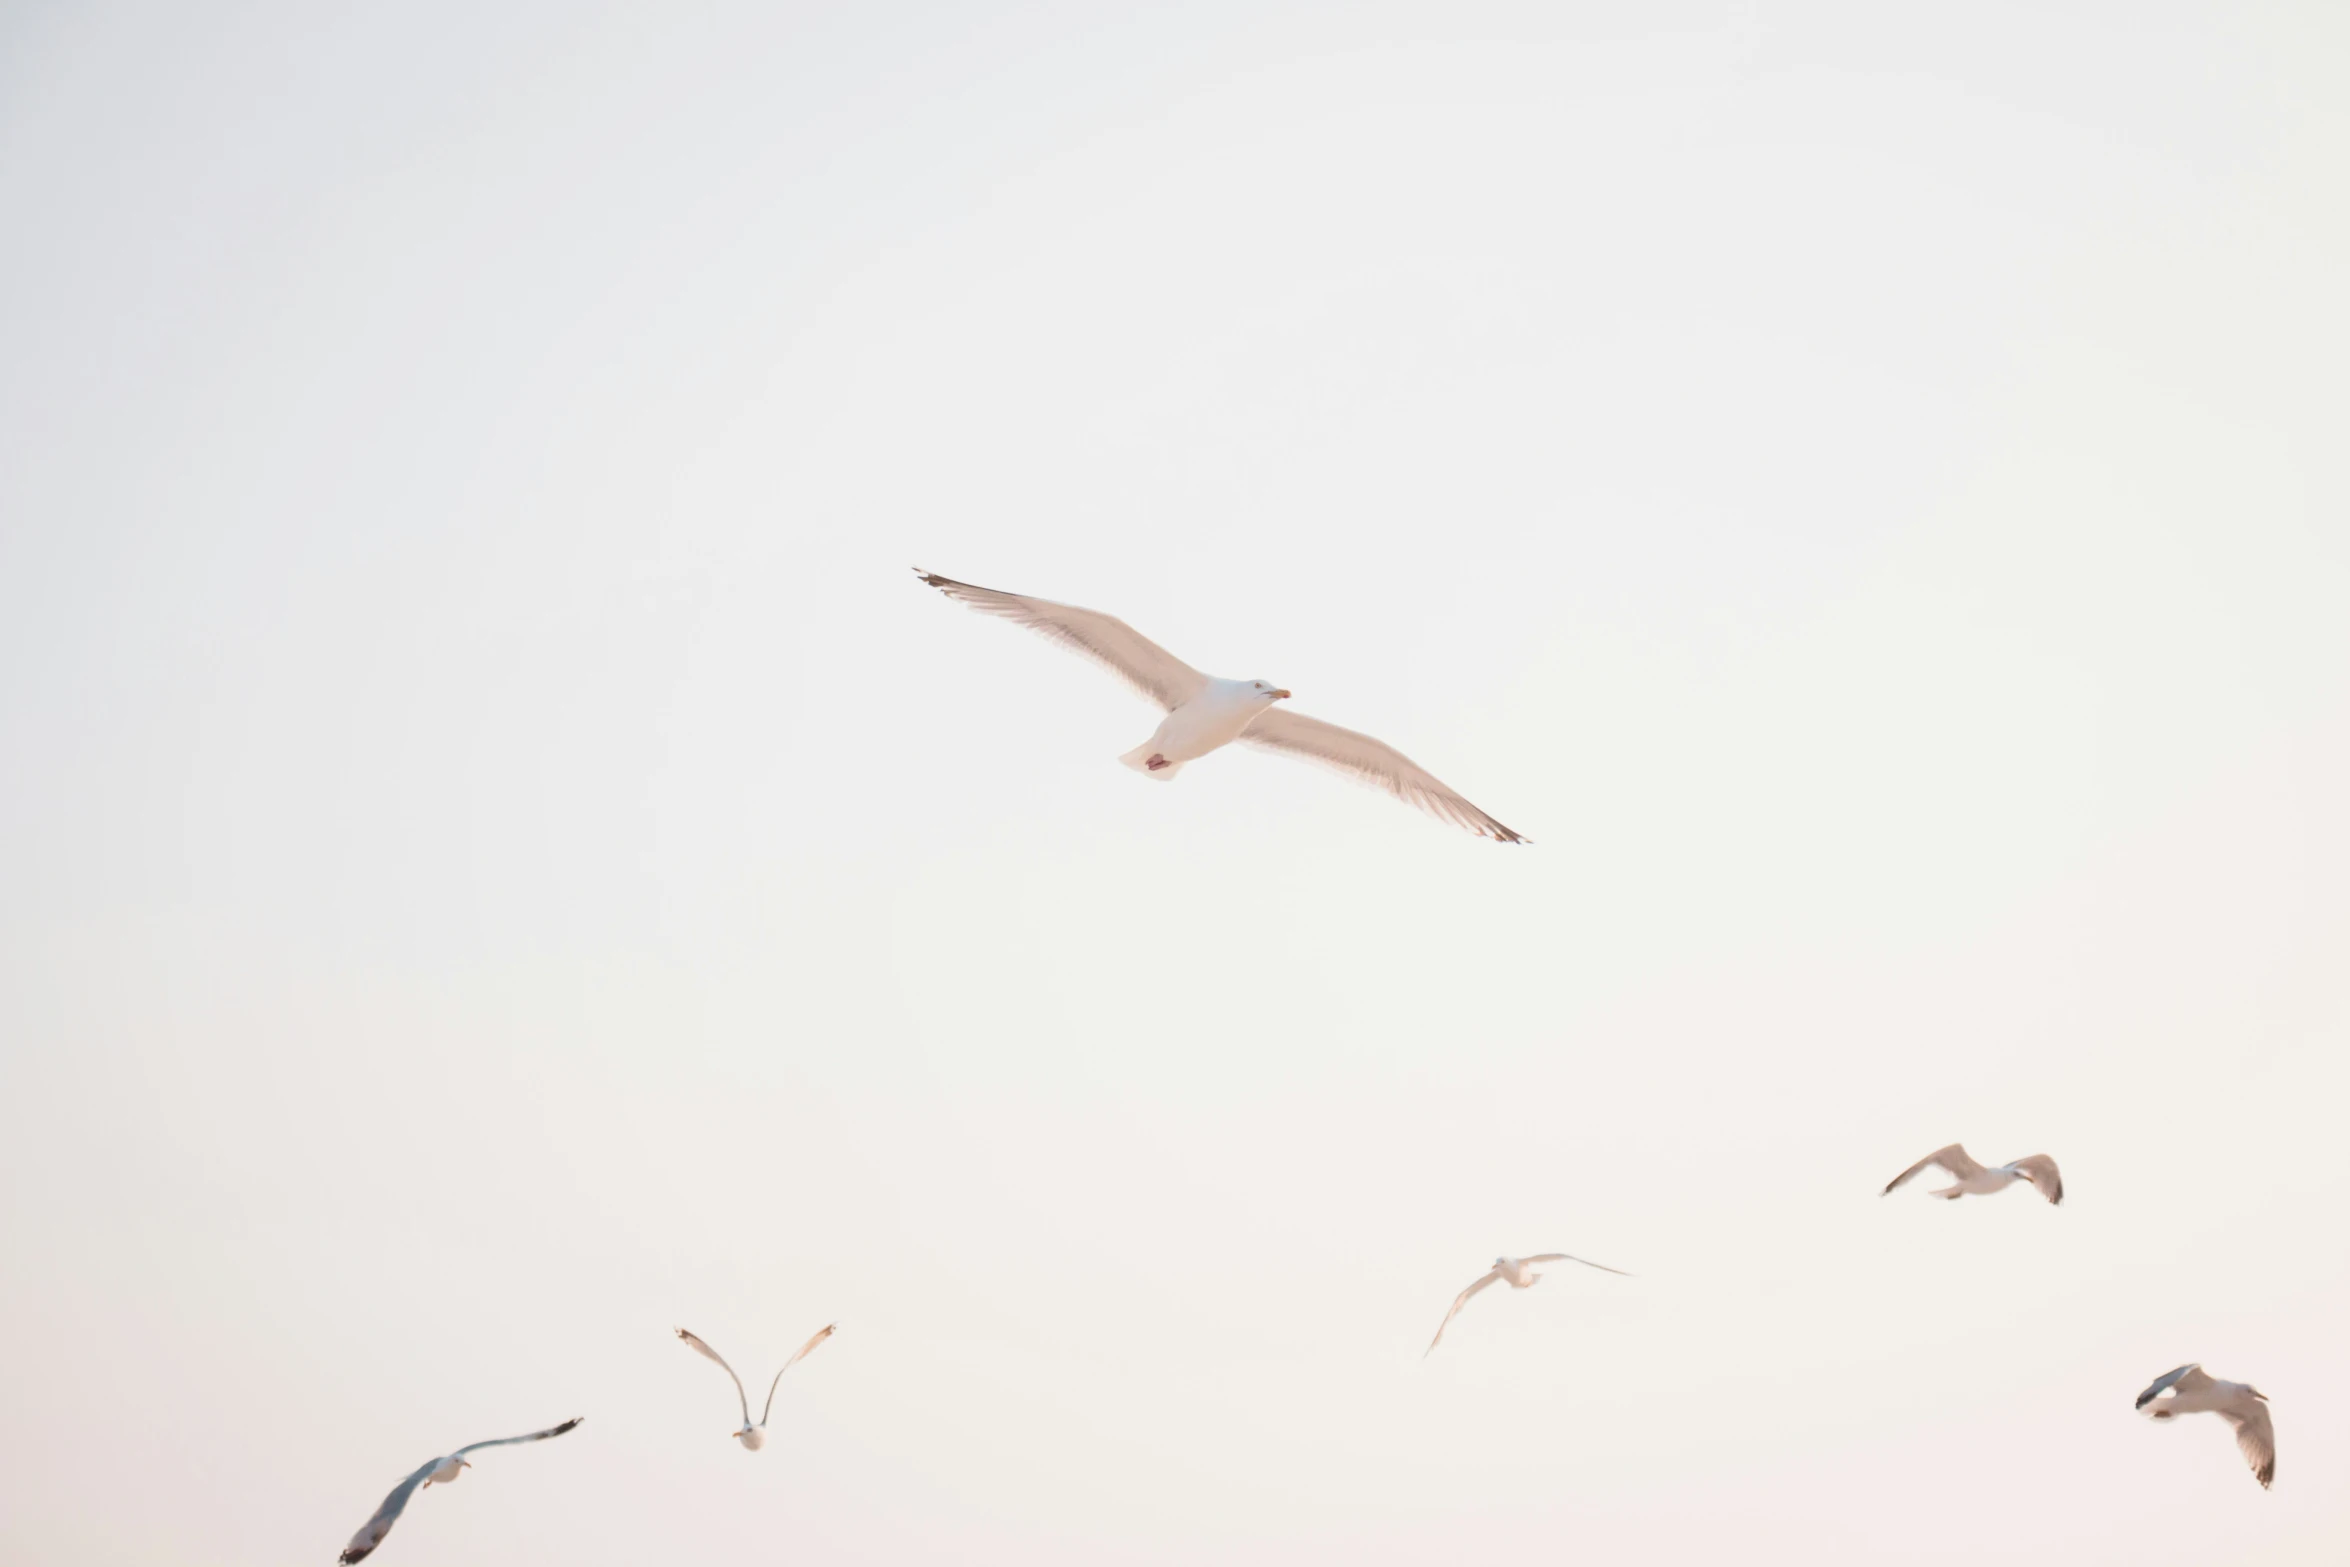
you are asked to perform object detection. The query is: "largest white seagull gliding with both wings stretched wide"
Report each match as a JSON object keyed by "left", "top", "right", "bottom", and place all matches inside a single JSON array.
[{"left": 914, "top": 566, "right": 1530, "bottom": 843}]
